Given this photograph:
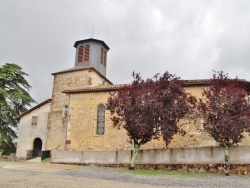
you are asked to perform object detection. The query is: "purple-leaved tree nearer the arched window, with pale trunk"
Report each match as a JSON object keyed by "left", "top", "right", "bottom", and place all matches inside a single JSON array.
[{"left": 107, "top": 72, "right": 195, "bottom": 169}]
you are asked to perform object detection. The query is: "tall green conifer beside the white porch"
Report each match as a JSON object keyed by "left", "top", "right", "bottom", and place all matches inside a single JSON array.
[{"left": 0, "top": 63, "right": 35, "bottom": 154}]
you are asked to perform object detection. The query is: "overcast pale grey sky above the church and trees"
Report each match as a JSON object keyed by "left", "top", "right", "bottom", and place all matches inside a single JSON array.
[{"left": 0, "top": 0, "right": 250, "bottom": 102}]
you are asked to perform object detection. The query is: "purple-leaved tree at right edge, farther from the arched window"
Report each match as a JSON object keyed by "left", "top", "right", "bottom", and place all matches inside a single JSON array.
[{"left": 198, "top": 71, "right": 250, "bottom": 176}]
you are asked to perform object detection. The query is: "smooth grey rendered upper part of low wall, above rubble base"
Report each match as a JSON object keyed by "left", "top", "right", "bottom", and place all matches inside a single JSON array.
[{"left": 51, "top": 146, "right": 250, "bottom": 164}]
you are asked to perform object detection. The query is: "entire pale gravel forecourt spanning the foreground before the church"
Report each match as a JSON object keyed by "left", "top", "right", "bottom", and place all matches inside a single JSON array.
[{"left": 0, "top": 163, "right": 250, "bottom": 188}]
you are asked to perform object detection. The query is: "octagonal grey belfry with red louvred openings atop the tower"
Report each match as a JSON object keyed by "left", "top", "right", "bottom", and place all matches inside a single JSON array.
[{"left": 74, "top": 38, "right": 109, "bottom": 77}]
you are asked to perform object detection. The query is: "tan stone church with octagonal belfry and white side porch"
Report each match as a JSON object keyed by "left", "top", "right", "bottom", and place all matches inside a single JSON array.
[{"left": 16, "top": 38, "right": 250, "bottom": 159}]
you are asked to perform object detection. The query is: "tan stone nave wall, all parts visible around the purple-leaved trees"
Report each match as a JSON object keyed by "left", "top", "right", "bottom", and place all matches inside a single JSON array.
[{"left": 62, "top": 87, "right": 216, "bottom": 151}]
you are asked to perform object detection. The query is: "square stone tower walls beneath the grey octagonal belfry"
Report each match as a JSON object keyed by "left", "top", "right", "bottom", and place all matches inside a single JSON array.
[{"left": 46, "top": 69, "right": 108, "bottom": 150}]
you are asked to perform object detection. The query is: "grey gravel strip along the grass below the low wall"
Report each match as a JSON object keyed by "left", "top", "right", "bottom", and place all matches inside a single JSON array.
[{"left": 51, "top": 167, "right": 250, "bottom": 188}]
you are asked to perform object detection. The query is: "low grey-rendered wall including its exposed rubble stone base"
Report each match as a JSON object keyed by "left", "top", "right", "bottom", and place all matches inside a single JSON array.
[{"left": 51, "top": 146, "right": 250, "bottom": 174}]
